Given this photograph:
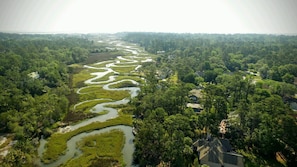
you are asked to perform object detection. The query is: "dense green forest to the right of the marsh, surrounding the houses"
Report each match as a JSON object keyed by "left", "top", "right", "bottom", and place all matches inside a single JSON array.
[{"left": 124, "top": 33, "right": 297, "bottom": 166}]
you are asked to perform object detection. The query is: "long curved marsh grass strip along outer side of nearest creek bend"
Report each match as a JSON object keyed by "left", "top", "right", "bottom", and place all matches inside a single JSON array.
[{"left": 42, "top": 114, "right": 132, "bottom": 163}]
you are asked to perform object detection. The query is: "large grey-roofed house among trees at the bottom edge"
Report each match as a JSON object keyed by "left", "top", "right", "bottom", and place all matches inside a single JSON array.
[{"left": 193, "top": 138, "right": 244, "bottom": 167}]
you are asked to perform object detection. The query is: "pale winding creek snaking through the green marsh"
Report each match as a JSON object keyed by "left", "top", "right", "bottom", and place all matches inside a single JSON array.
[{"left": 38, "top": 41, "right": 148, "bottom": 167}]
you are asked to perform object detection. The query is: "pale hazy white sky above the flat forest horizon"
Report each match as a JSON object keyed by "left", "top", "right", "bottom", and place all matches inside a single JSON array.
[{"left": 0, "top": 0, "right": 297, "bottom": 34}]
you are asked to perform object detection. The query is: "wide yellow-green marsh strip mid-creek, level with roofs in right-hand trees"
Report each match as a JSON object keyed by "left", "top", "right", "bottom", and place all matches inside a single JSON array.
[{"left": 79, "top": 86, "right": 130, "bottom": 101}]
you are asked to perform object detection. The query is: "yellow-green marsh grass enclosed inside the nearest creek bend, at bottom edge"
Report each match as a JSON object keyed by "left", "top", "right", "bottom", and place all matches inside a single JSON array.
[{"left": 64, "top": 130, "right": 125, "bottom": 167}]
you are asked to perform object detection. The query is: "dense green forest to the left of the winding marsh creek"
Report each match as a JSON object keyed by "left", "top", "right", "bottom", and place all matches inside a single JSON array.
[{"left": 0, "top": 33, "right": 99, "bottom": 165}]
